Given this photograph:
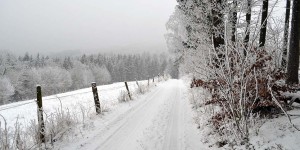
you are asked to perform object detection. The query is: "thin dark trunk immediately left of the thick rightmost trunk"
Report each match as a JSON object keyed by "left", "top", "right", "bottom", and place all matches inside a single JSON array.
[{"left": 281, "top": 0, "right": 291, "bottom": 69}]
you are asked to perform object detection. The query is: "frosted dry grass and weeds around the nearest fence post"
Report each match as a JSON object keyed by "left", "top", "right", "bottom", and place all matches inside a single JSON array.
[{"left": 0, "top": 105, "right": 85, "bottom": 150}]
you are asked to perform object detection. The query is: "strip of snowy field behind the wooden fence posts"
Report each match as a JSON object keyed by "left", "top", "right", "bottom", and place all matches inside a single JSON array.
[{"left": 0, "top": 81, "right": 148, "bottom": 131}]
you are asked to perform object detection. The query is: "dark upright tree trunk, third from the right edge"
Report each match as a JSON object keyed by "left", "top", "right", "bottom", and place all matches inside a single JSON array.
[{"left": 259, "top": 0, "right": 269, "bottom": 47}]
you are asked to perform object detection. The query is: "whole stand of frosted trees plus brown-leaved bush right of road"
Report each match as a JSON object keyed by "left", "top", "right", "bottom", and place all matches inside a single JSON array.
[{"left": 166, "top": 0, "right": 300, "bottom": 143}]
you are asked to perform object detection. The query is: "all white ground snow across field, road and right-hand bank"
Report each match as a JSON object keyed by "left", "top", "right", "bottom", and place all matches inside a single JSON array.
[{"left": 0, "top": 80, "right": 300, "bottom": 150}]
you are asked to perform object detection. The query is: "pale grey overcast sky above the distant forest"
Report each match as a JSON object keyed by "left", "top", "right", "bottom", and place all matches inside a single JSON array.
[{"left": 0, "top": 0, "right": 176, "bottom": 53}]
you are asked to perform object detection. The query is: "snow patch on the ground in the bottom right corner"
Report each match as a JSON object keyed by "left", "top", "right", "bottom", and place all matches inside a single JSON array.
[{"left": 250, "top": 105, "right": 300, "bottom": 150}]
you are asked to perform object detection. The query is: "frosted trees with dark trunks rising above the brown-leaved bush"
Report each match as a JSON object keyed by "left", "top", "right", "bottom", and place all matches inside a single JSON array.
[{"left": 166, "top": 0, "right": 300, "bottom": 85}]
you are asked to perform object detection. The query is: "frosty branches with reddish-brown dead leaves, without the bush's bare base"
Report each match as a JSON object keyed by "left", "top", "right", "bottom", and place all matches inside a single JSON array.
[{"left": 190, "top": 49, "right": 293, "bottom": 128}]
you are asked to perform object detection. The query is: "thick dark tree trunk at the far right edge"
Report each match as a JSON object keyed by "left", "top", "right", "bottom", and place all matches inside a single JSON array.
[{"left": 286, "top": 0, "right": 300, "bottom": 85}]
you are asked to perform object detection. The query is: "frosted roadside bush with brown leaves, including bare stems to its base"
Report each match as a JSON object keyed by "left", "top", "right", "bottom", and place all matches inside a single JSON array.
[{"left": 195, "top": 47, "right": 289, "bottom": 143}]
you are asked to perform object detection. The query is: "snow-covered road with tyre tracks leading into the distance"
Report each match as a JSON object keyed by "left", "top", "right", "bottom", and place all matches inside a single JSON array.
[{"left": 59, "top": 80, "right": 205, "bottom": 150}]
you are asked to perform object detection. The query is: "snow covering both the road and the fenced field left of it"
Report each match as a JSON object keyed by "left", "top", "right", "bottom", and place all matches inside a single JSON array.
[{"left": 1, "top": 80, "right": 207, "bottom": 150}]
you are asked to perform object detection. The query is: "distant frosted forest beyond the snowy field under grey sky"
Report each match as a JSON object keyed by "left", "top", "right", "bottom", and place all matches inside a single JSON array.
[{"left": 0, "top": 52, "right": 178, "bottom": 104}]
